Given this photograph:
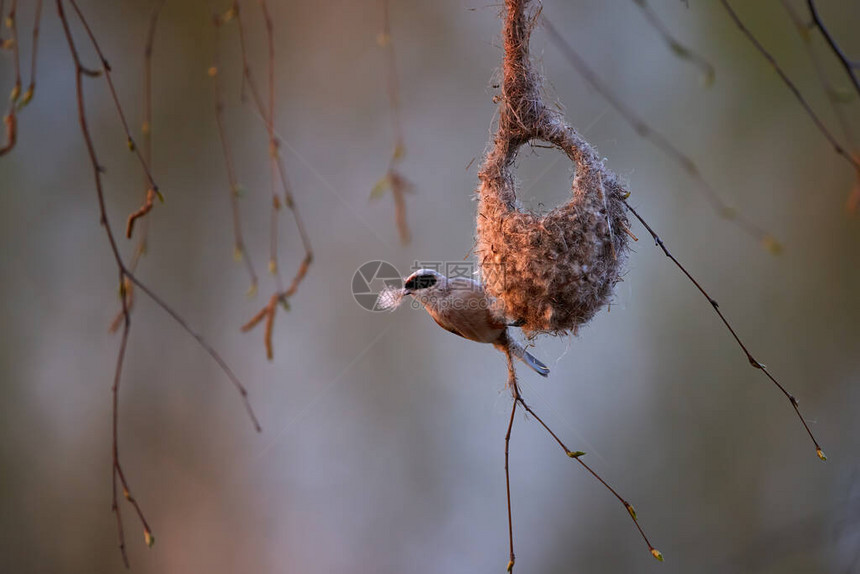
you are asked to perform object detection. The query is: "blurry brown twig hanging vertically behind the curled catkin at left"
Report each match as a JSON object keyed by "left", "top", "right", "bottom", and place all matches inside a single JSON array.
[{"left": 110, "top": 0, "right": 165, "bottom": 333}]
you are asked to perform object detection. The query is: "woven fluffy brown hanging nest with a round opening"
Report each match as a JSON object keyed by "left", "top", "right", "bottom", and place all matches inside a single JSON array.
[{"left": 476, "top": 0, "right": 629, "bottom": 336}]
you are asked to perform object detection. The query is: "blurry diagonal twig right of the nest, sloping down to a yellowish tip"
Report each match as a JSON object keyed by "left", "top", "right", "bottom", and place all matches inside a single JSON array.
[{"left": 541, "top": 17, "right": 782, "bottom": 254}]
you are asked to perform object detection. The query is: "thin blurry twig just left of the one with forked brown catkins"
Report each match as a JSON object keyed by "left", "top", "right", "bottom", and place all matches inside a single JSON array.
[{"left": 209, "top": 9, "right": 257, "bottom": 296}]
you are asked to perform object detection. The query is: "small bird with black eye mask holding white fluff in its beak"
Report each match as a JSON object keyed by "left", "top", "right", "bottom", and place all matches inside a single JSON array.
[{"left": 380, "top": 269, "right": 549, "bottom": 377}]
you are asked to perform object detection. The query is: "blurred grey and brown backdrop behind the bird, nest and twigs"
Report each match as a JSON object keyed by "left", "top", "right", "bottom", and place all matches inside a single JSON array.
[{"left": 0, "top": 0, "right": 860, "bottom": 574}]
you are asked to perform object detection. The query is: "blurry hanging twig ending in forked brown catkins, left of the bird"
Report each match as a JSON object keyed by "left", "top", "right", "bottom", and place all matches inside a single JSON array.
[{"left": 210, "top": 0, "right": 313, "bottom": 360}]
